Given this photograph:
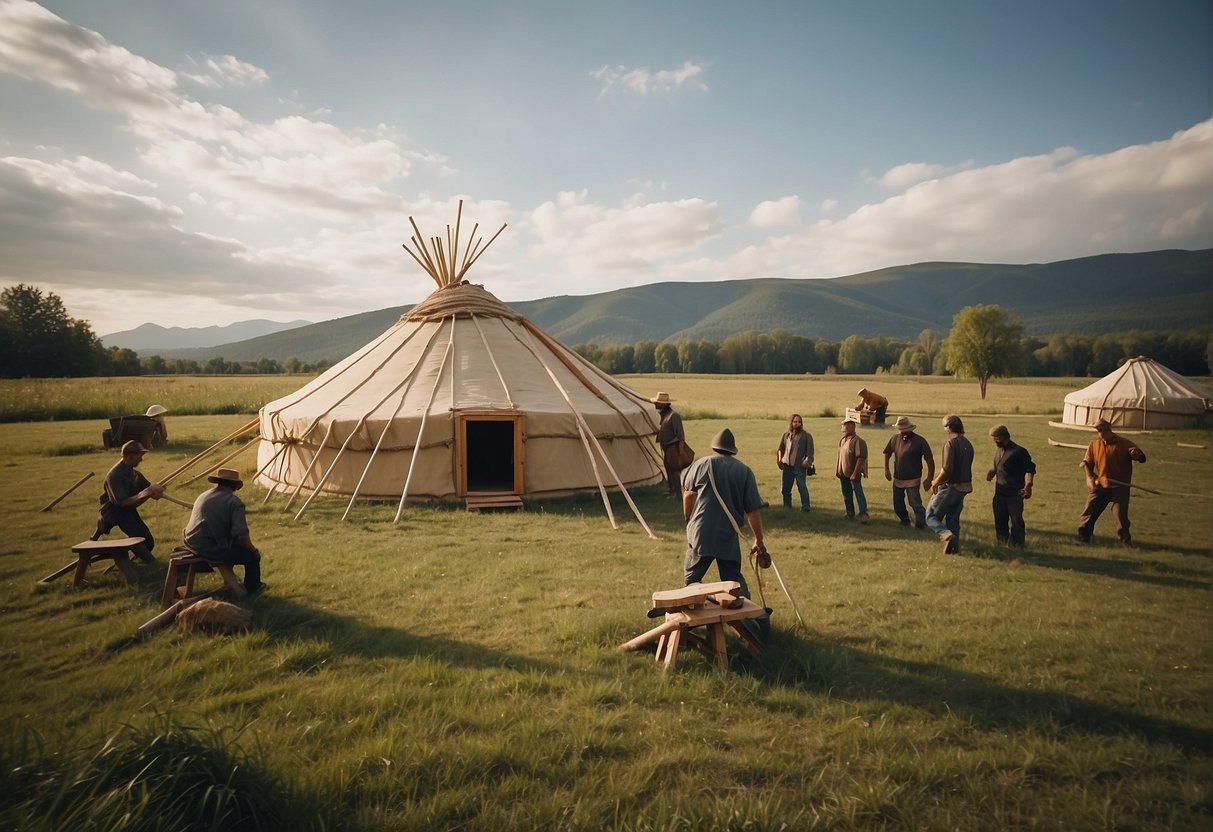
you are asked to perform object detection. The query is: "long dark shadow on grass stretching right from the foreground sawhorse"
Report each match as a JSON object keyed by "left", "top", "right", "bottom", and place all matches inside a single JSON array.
[{"left": 734, "top": 632, "right": 1213, "bottom": 757}]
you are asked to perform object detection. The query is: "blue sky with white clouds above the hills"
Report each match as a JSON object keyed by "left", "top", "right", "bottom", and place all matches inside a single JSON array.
[{"left": 0, "top": 0, "right": 1213, "bottom": 335}]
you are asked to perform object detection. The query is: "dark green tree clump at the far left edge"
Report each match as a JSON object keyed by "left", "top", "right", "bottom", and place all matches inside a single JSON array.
[{"left": 0, "top": 284, "right": 103, "bottom": 378}]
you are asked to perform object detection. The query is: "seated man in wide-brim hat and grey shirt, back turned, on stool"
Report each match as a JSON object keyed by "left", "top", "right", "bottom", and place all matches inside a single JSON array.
[{"left": 183, "top": 468, "right": 266, "bottom": 594}]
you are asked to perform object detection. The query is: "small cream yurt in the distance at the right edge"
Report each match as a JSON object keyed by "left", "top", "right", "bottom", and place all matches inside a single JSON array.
[{"left": 1061, "top": 355, "right": 1213, "bottom": 429}]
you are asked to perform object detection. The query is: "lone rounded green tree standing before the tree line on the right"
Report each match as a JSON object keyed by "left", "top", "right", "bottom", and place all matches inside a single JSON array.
[{"left": 945, "top": 303, "right": 1024, "bottom": 399}]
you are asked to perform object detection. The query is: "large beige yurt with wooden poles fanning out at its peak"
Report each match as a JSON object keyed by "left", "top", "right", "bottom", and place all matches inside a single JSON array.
[{"left": 256, "top": 204, "right": 662, "bottom": 534}]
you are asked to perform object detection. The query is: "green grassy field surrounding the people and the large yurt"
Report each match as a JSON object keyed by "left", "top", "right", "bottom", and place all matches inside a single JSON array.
[{"left": 0, "top": 376, "right": 1213, "bottom": 831}]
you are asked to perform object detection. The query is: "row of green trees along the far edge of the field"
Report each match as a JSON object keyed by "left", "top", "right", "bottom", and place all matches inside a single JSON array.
[{"left": 0, "top": 284, "right": 1213, "bottom": 388}]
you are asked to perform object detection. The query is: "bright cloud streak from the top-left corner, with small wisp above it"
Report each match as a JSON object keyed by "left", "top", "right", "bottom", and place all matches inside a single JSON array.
[{"left": 0, "top": 2, "right": 422, "bottom": 221}]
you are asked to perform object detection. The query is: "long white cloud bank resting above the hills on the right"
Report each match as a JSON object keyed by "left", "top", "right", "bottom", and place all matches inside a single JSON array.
[{"left": 717, "top": 121, "right": 1213, "bottom": 278}]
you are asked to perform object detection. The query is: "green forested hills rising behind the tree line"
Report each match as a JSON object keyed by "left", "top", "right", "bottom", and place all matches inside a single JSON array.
[{"left": 160, "top": 250, "right": 1213, "bottom": 361}]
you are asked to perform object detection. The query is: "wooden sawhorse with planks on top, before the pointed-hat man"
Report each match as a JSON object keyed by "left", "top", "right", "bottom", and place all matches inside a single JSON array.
[{"left": 620, "top": 581, "right": 767, "bottom": 671}]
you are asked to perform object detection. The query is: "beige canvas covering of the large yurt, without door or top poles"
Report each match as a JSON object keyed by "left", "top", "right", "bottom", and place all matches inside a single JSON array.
[{"left": 249, "top": 297, "right": 662, "bottom": 500}]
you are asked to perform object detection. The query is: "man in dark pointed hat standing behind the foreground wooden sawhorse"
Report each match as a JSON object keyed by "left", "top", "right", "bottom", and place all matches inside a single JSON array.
[{"left": 682, "top": 428, "right": 770, "bottom": 634}]
